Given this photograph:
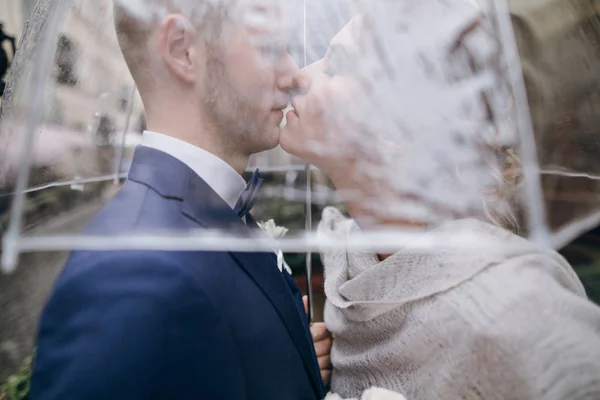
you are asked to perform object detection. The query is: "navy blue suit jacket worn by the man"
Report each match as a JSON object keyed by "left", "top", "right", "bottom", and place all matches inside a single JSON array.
[{"left": 32, "top": 147, "right": 324, "bottom": 400}]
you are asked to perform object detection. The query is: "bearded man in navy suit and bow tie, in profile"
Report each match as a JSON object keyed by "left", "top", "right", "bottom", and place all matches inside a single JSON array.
[{"left": 32, "top": 0, "right": 330, "bottom": 400}]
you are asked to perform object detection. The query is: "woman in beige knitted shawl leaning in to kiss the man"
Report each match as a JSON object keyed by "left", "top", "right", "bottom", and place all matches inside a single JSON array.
[{"left": 281, "top": 0, "right": 600, "bottom": 400}]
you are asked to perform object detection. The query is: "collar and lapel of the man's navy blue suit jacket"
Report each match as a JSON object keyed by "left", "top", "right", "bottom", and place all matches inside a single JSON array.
[{"left": 129, "top": 146, "right": 325, "bottom": 398}]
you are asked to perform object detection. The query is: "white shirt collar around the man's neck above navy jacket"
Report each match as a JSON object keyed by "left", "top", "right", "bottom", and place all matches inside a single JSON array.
[{"left": 141, "top": 131, "right": 246, "bottom": 208}]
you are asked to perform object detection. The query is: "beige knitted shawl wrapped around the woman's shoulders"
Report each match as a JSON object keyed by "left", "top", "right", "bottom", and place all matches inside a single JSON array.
[{"left": 319, "top": 208, "right": 600, "bottom": 400}]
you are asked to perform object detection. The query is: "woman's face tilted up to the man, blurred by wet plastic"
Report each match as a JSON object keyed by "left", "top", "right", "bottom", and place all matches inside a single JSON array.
[{"left": 280, "top": 18, "right": 364, "bottom": 176}]
